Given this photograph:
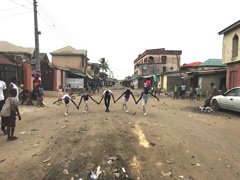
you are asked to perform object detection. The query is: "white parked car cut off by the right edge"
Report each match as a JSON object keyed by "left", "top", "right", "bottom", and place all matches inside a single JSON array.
[{"left": 211, "top": 87, "right": 240, "bottom": 112}]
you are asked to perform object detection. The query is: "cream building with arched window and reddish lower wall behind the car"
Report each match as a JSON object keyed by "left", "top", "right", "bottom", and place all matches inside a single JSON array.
[{"left": 218, "top": 21, "right": 240, "bottom": 89}]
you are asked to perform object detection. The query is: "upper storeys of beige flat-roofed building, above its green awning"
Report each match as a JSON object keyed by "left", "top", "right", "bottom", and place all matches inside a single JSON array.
[{"left": 134, "top": 48, "right": 182, "bottom": 76}]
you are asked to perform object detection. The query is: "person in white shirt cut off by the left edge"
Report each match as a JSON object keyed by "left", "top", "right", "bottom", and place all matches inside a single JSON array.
[{"left": 0, "top": 73, "right": 7, "bottom": 134}]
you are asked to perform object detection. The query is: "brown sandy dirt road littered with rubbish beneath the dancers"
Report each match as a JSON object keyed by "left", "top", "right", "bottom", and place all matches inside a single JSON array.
[{"left": 0, "top": 87, "right": 240, "bottom": 180}]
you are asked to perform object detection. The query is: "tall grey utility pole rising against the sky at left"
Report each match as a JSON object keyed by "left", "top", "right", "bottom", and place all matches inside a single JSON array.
[{"left": 33, "top": 0, "right": 40, "bottom": 69}]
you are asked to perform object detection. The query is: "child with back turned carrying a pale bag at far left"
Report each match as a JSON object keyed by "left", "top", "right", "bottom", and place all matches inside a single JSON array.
[{"left": 1, "top": 88, "right": 21, "bottom": 141}]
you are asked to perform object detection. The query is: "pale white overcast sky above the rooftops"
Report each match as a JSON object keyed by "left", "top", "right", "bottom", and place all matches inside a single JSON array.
[{"left": 0, "top": 0, "right": 240, "bottom": 79}]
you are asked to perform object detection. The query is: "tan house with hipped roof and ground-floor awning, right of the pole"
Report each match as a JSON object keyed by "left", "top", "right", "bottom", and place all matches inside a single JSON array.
[{"left": 50, "top": 46, "right": 89, "bottom": 90}]
